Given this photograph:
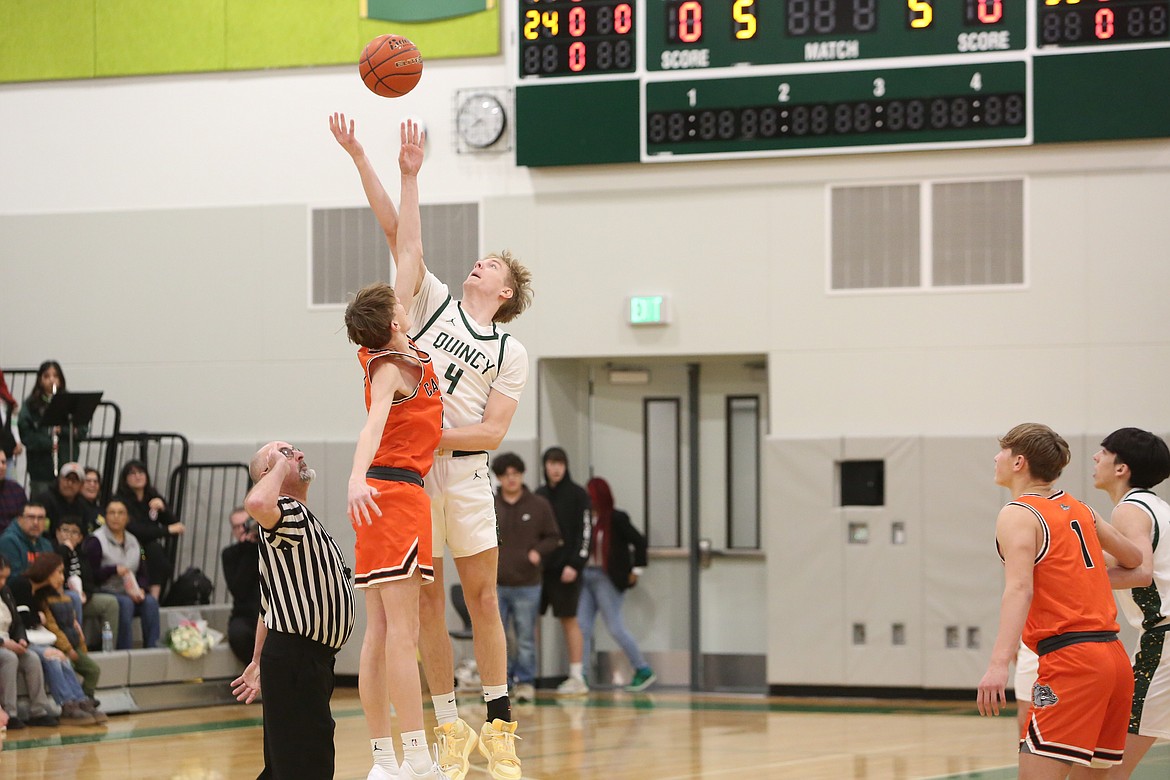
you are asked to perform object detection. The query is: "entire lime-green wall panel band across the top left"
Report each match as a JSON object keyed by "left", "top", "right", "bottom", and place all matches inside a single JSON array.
[{"left": 0, "top": 0, "right": 500, "bottom": 82}]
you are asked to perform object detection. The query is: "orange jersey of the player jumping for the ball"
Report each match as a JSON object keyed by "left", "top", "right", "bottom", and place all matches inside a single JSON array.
[{"left": 358, "top": 341, "right": 442, "bottom": 476}]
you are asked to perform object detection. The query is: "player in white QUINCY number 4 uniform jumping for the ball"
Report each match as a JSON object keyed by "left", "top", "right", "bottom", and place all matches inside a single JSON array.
[{"left": 330, "top": 115, "right": 532, "bottom": 780}]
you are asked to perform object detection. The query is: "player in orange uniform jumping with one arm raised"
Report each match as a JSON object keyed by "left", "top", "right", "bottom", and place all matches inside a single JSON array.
[{"left": 345, "top": 122, "right": 447, "bottom": 780}]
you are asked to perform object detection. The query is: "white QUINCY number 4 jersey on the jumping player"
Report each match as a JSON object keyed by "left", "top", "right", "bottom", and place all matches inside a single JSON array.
[{"left": 411, "top": 271, "right": 528, "bottom": 428}]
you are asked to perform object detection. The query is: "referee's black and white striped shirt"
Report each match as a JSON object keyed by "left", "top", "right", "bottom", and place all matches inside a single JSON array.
[{"left": 260, "top": 496, "right": 355, "bottom": 649}]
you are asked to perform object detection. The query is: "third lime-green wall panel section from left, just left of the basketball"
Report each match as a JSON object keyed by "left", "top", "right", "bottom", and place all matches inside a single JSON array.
[{"left": 226, "top": 0, "right": 362, "bottom": 70}]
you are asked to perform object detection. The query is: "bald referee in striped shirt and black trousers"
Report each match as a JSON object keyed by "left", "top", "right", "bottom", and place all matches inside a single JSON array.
[{"left": 232, "top": 441, "right": 353, "bottom": 780}]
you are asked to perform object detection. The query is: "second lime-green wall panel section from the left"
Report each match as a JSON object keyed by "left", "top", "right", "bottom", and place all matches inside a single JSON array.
[{"left": 96, "top": 0, "right": 225, "bottom": 76}]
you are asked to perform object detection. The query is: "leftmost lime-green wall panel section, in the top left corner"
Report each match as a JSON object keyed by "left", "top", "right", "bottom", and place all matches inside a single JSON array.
[{"left": 0, "top": 0, "right": 94, "bottom": 82}]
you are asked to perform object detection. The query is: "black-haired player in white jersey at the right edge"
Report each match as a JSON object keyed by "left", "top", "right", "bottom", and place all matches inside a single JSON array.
[{"left": 1093, "top": 428, "right": 1170, "bottom": 780}]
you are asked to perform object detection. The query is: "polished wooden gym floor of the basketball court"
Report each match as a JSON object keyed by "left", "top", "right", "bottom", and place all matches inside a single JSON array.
[{"left": 0, "top": 689, "right": 1170, "bottom": 780}]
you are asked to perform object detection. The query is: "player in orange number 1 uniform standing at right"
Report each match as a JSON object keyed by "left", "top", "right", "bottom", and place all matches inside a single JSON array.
[{"left": 978, "top": 422, "right": 1142, "bottom": 780}]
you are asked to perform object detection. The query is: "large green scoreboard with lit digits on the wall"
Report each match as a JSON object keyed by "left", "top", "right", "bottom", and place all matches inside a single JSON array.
[{"left": 512, "top": 0, "right": 1170, "bottom": 166}]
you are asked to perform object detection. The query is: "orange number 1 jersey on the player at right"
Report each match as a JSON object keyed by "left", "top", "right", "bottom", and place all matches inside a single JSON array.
[{"left": 1011, "top": 490, "right": 1117, "bottom": 651}]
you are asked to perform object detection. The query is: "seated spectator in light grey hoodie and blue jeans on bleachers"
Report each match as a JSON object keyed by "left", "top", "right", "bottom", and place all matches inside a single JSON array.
[{"left": 82, "top": 498, "right": 159, "bottom": 650}]
